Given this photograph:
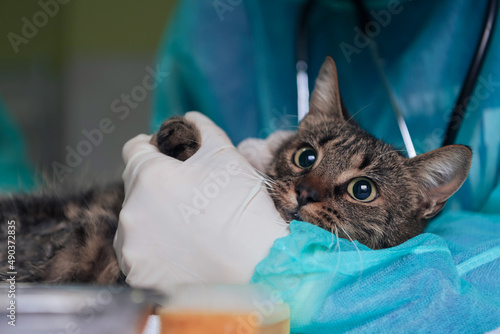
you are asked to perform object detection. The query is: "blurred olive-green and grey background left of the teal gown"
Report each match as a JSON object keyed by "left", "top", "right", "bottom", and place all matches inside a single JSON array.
[{"left": 0, "top": 0, "right": 175, "bottom": 185}]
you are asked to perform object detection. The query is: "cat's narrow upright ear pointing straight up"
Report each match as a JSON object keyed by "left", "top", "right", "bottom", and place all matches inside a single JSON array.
[{"left": 304, "top": 56, "right": 345, "bottom": 126}]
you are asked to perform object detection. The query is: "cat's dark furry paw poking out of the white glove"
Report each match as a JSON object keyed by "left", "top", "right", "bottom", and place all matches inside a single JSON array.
[{"left": 151, "top": 117, "right": 201, "bottom": 161}]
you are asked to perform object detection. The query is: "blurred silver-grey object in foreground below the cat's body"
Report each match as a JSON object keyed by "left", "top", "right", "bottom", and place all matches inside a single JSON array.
[{"left": 0, "top": 283, "right": 162, "bottom": 334}]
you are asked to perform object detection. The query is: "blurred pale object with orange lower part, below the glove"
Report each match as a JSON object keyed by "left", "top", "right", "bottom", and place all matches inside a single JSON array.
[{"left": 159, "top": 284, "right": 290, "bottom": 334}]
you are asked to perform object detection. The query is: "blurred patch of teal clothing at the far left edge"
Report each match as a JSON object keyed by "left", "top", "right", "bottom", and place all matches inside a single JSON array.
[{"left": 0, "top": 99, "right": 35, "bottom": 193}]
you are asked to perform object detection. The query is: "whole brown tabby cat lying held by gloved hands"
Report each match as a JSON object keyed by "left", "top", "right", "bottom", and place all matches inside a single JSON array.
[{"left": 0, "top": 57, "right": 471, "bottom": 283}]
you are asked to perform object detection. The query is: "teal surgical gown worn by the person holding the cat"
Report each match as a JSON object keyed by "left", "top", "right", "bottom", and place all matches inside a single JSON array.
[{"left": 152, "top": 0, "right": 500, "bottom": 333}]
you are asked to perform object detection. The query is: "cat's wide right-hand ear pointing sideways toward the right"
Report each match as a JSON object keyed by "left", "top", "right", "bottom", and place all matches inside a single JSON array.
[{"left": 406, "top": 145, "right": 472, "bottom": 218}]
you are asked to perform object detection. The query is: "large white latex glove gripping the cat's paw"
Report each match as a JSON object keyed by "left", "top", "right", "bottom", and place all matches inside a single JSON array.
[{"left": 114, "top": 112, "right": 289, "bottom": 291}]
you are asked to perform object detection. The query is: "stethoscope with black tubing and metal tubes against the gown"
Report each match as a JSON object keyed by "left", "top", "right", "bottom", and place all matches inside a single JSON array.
[{"left": 296, "top": 0, "right": 498, "bottom": 158}]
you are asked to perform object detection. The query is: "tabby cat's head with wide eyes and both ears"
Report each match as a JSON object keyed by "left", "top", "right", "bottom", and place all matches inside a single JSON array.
[{"left": 267, "top": 57, "right": 472, "bottom": 248}]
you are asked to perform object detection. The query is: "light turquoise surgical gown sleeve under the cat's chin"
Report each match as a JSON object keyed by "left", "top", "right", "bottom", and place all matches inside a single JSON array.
[{"left": 252, "top": 219, "right": 500, "bottom": 334}]
